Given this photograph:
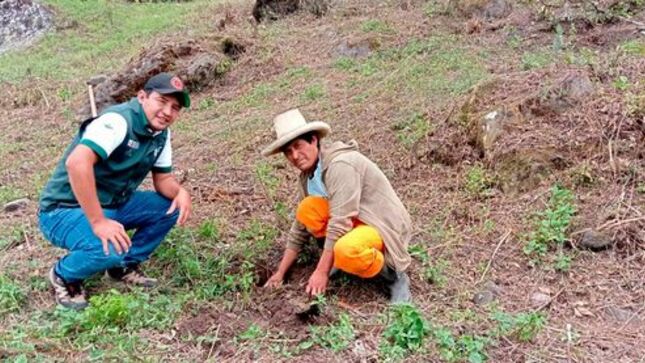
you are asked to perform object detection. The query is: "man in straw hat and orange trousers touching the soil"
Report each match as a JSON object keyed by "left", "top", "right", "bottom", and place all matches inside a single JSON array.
[{"left": 262, "top": 109, "right": 412, "bottom": 303}]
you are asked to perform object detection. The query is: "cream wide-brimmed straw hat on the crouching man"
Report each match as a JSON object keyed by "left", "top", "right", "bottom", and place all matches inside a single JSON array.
[{"left": 262, "top": 108, "right": 331, "bottom": 156}]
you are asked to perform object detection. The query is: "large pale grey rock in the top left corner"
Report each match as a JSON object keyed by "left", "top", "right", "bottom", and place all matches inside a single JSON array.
[{"left": 0, "top": 0, "right": 53, "bottom": 54}]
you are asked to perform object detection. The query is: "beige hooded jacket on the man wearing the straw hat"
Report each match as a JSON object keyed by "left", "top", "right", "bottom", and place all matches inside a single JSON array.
[{"left": 287, "top": 140, "right": 412, "bottom": 271}]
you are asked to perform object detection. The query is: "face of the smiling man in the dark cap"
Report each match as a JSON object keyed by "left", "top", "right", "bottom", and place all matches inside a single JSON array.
[{"left": 137, "top": 91, "right": 181, "bottom": 131}]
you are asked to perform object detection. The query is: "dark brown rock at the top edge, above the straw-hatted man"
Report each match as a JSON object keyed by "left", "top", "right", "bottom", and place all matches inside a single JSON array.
[{"left": 252, "top": 0, "right": 329, "bottom": 23}]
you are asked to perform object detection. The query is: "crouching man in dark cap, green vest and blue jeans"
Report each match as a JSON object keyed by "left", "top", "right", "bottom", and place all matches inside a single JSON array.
[{"left": 38, "top": 73, "right": 191, "bottom": 309}]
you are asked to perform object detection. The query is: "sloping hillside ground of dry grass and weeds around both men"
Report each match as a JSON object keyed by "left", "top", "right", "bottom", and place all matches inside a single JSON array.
[{"left": 0, "top": 0, "right": 645, "bottom": 362}]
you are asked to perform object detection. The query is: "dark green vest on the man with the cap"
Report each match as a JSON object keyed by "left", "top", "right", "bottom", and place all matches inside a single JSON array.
[{"left": 40, "top": 98, "right": 170, "bottom": 212}]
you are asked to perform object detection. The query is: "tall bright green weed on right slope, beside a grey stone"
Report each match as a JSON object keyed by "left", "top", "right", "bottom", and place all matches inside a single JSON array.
[{"left": 524, "top": 185, "right": 576, "bottom": 259}]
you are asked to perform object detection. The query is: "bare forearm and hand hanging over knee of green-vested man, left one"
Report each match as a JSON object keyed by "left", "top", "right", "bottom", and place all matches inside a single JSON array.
[{"left": 65, "top": 144, "right": 132, "bottom": 255}]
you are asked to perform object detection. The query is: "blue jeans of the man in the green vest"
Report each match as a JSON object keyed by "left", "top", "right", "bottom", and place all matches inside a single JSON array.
[{"left": 38, "top": 191, "right": 179, "bottom": 283}]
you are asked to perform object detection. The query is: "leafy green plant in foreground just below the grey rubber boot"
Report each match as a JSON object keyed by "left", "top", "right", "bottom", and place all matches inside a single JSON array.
[{"left": 381, "top": 303, "right": 430, "bottom": 352}]
